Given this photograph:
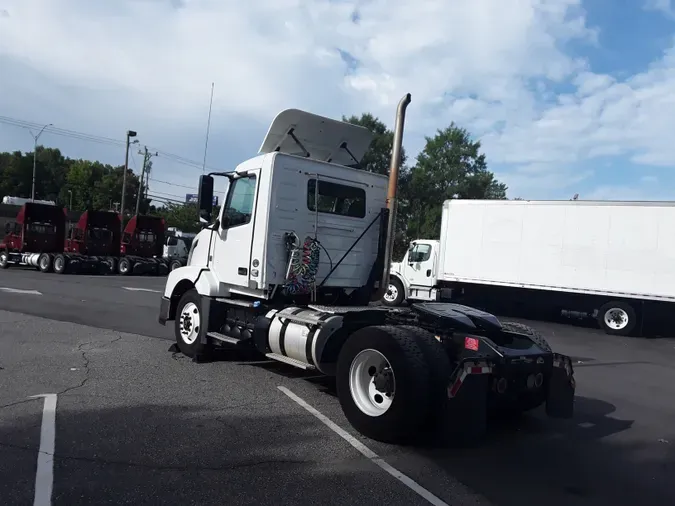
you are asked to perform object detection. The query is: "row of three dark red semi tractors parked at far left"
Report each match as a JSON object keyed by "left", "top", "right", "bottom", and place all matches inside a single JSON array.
[{"left": 0, "top": 202, "right": 177, "bottom": 276}]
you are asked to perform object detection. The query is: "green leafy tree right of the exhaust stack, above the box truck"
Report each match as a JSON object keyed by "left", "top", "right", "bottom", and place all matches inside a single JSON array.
[{"left": 407, "top": 123, "right": 507, "bottom": 239}]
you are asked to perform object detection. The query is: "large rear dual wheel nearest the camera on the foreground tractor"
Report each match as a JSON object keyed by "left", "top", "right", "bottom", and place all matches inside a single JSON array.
[{"left": 336, "top": 326, "right": 431, "bottom": 443}]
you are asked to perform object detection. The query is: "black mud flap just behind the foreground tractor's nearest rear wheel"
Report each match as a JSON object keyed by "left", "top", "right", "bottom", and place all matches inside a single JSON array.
[{"left": 437, "top": 374, "right": 490, "bottom": 446}]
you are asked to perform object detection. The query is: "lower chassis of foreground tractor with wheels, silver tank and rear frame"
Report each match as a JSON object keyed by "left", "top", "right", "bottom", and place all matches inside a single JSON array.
[{"left": 159, "top": 287, "right": 576, "bottom": 443}]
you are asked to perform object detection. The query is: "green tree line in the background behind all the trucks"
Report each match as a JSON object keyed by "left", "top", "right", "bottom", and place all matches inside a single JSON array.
[{"left": 0, "top": 113, "right": 507, "bottom": 251}]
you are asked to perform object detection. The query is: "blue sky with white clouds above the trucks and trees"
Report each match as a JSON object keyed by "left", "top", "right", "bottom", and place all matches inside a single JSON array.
[{"left": 0, "top": 0, "right": 675, "bottom": 200}]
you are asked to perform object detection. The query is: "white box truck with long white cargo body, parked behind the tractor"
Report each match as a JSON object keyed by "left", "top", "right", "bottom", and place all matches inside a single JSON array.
[{"left": 382, "top": 200, "right": 675, "bottom": 335}]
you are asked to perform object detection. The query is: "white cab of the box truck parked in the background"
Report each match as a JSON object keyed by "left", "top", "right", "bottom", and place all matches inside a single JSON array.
[{"left": 382, "top": 239, "right": 447, "bottom": 306}]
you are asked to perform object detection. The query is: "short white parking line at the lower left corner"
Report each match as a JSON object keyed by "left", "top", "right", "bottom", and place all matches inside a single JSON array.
[{"left": 31, "top": 394, "right": 56, "bottom": 506}]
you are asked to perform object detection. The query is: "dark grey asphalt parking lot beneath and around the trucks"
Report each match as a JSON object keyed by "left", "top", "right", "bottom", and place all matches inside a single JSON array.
[{"left": 0, "top": 269, "right": 675, "bottom": 506}]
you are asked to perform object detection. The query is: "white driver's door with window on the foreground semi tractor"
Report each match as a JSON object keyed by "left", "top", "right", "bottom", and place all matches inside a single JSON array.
[{"left": 212, "top": 170, "right": 260, "bottom": 288}]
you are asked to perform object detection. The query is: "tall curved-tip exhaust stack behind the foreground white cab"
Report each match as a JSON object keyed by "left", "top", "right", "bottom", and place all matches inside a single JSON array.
[{"left": 372, "top": 93, "right": 411, "bottom": 301}]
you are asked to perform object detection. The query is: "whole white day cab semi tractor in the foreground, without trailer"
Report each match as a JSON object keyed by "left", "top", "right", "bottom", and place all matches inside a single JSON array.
[{"left": 159, "top": 95, "right": 575, "bottom": 443}]
